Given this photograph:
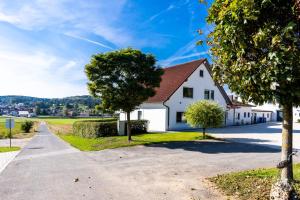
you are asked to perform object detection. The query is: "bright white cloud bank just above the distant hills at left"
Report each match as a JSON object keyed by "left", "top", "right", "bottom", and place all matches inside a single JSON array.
[{"left": 0, "top": 50, "right": 87, "bottom": 97}]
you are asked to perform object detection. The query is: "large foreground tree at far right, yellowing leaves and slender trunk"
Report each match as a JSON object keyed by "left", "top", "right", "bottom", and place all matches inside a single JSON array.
[{"left": 207, "top": 0, "right": 300, "bottom": 182}]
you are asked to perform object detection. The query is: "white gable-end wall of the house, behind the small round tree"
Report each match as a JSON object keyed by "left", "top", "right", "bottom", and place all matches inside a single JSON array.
[{"left": 165, "top": 64, "right": 227, "bottom": 130}]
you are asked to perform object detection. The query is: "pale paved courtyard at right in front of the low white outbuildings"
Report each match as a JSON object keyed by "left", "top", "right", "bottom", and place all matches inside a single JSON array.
[{"left": 208, "top": 122, "right": 300, "bottom": 149}]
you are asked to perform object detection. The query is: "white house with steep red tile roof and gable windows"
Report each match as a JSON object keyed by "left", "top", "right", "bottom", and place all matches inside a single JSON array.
[{"left": 120, "top": 59, "right": 232, "bottom": 131}]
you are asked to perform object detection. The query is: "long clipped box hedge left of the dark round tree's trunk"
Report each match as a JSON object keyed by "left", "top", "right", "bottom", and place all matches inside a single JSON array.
[{"left": 73, "top": 120, "right": 118, "bottom": 138}]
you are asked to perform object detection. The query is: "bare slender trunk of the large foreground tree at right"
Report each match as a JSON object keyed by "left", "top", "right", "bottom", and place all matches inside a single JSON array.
[{"left": 281, "top": 104, "right": 293, "bottom": 182}]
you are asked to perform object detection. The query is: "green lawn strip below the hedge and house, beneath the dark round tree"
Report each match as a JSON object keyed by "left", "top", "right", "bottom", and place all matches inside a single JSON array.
[{"left": 59, "top": 132, "right": 212, "bottom": 151}]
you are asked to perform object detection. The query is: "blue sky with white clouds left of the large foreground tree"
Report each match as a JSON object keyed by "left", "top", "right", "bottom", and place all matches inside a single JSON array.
[{"left": 0, "top": 0, "right": 208, "bottom": 97}]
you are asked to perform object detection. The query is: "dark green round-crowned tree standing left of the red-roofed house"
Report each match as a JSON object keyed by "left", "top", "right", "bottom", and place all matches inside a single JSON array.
[{"left": 85, "top": 48, "right": 163, "bottom": 141}]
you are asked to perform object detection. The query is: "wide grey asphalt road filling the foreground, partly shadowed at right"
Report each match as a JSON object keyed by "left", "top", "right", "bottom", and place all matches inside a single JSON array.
[{"left": 0, "top": 124, "right": 299, "bottom": 200}]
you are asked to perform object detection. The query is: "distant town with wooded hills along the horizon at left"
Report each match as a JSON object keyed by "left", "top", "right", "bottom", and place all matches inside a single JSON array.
[{"left": 0, "top": 95, "right": 103, "bottom": 118}]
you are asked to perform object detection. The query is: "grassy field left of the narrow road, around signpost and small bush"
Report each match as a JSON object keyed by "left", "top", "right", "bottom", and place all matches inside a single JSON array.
[{"left": 0, "top": 117, "right": 35, "bottom": 139}]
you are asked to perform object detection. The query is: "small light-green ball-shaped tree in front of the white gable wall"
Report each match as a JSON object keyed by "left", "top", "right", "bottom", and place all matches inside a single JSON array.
[{"left": 184, "top": 100, "right": 225, "bottom": 138}]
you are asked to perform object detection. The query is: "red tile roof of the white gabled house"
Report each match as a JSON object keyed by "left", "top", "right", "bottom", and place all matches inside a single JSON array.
[{"left": 147, "top": 59, "right": 230, "bottom": 104}]
